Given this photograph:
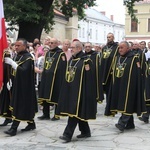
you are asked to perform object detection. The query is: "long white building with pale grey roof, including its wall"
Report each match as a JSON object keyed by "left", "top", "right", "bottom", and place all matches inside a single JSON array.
[{"left": 78, "top": 8, "right": 125, "bottom": 44}]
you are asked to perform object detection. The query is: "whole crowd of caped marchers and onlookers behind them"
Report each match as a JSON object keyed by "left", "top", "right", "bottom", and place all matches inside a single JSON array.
[{"left": 0, "top": 33, "right": 150, "bottom": 142}]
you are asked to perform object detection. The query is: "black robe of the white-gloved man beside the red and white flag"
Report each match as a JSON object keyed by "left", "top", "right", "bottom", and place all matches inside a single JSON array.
[{"left": 11, "top": 50, "right": 37, "bottom": 121}]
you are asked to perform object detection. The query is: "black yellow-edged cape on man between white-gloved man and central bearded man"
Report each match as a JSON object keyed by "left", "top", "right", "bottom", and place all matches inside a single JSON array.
[{"left": 38, "top": 47, "right": 67, "bottom": 104}]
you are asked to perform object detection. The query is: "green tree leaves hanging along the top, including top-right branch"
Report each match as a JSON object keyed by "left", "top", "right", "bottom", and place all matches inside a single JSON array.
[{"left": 3, "top": 0, "right": 142, "bottom": 32}]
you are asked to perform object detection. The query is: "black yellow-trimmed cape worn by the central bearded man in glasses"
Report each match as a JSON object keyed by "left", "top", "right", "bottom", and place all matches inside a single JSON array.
[{"left": 57, "top": 51, "right": 97, "bottom": 120}]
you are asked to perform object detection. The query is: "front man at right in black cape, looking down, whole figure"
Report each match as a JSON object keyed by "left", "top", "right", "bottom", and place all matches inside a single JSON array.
[{"left": 107, "top": 41, "right": 146, "bottom": 131}]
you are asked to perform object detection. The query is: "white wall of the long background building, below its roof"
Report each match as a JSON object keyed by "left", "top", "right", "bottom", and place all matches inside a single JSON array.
[{"left": 78, "top": 17, "right": 125, "bottom": 44}]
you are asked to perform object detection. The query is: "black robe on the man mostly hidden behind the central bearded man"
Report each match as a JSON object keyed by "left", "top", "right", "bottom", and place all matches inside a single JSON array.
[{"left": 85, "top": 50, "right": 104, "bottom": 103}]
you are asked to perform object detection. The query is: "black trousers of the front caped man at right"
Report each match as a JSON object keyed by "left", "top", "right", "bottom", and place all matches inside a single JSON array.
[{"left": 118, "top": 114, "right": 134, "bottom": 128}]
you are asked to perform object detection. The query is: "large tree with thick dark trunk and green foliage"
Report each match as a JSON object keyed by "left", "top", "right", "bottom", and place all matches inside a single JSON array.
[{"left": 4, "top": 0, "right": 142, "bottom": 42}]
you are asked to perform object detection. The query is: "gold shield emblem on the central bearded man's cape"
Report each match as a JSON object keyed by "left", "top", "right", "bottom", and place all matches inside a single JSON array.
[{"left": 66, "top": 66, "right": 76, "bottom": 82}]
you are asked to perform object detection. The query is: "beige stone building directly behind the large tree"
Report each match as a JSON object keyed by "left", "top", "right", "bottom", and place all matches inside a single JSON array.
[{"left": 41, "top": 10, "right": 78, "bottom": 41}]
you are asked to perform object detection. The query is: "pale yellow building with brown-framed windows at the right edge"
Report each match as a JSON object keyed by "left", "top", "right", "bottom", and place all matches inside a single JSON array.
[{"left": 125, "top": 0, "right": 150, "bottom": 42}]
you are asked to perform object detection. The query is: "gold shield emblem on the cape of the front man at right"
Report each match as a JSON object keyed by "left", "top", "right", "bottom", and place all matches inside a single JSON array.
[{"left": 115, "top": 63, "right": 126, "bottom": 78}]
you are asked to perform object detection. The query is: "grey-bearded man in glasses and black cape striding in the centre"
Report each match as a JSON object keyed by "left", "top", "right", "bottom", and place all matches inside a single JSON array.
[{"left": 57, "top": 41, "right": 97, "bottom": 142}]
